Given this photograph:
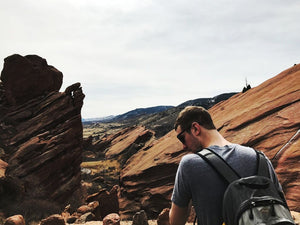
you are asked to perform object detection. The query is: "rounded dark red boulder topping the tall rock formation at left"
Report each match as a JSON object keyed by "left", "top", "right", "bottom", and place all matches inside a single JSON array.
[{"left": 1, "top": 54, "right": 63, "bottom": 105}]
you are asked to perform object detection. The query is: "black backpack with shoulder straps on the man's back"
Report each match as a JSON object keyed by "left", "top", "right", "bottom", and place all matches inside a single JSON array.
[{"left": 197, "top": 149, "right": 295, "bottom": 225}]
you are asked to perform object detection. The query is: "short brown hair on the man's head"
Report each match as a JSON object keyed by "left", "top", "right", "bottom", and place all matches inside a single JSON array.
[{"left": 174, "top": 106, "right": 216, "bottom": 130}]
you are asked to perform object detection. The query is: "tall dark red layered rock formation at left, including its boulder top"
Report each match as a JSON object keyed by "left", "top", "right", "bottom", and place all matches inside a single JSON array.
[{"left": 0, "top": 55, "right": 84, "bottom": 213}]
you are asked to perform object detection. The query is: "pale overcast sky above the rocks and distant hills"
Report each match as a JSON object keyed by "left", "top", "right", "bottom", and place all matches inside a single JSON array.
[{"left": 0, "top": 0, "right": 300, "bottom": 118}]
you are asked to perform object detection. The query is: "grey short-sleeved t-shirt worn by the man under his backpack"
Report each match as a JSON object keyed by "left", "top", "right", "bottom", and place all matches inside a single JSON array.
[{"left": 171, "top": 144, "right": 281, "bottom": 225}]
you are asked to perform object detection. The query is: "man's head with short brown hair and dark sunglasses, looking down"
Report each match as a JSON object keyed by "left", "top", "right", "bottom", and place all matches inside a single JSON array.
[{"left": 174, "top": 106, "right": 216, "bottom": 151}]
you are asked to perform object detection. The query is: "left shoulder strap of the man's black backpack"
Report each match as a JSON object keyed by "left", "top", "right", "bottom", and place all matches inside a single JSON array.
[{"left": 196, "top": 148, "right": 241, "bottom": 183}]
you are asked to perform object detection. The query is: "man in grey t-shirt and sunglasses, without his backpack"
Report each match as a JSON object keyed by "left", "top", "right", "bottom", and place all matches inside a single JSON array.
[{"left": 169, "top": 106, "right": 280, "bottom": 225}]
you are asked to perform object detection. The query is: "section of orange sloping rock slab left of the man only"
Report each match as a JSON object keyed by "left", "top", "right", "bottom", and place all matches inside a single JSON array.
[{"left": 119, "top": 131, "right": 185, "bottom": 219}]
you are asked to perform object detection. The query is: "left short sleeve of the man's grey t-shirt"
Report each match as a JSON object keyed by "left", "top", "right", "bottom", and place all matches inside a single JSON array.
[{"left": 171, "top": 156, "right": 191, "bottom": 207}]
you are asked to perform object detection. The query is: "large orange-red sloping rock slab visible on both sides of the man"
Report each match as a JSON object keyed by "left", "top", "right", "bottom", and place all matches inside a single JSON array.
[{"left": 120, "top": 65, "right": 300, "bottom": 219}]
